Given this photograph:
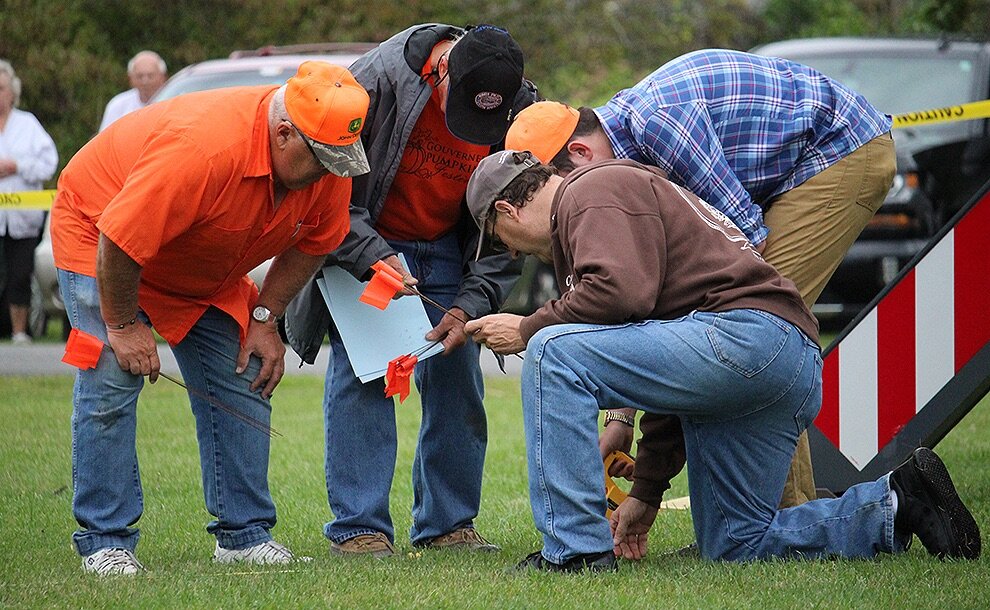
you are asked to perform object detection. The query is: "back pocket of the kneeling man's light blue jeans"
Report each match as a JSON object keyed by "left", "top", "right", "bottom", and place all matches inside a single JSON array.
[{"left": 706, "top": 309, "right": 791, "bottom": 378}]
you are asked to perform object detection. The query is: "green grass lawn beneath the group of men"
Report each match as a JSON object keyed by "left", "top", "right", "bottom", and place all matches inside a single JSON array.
[{"left": 0, "top": 377, "right": 990, "bottom": 609}]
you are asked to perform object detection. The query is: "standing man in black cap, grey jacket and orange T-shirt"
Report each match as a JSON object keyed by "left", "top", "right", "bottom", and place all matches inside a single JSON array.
[{"left": 285, "top": 23, "right": 537, "bottom": 557}]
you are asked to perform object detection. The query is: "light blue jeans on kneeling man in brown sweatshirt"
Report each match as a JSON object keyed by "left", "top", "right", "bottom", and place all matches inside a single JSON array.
[{"left": 522, "top": 309, "right": 903, "bottom": 563}]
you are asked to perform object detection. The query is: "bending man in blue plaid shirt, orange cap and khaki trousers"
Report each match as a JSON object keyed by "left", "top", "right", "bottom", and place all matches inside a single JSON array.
[{"left": 506, "top": 49, "right": 896, "bottom": 508}]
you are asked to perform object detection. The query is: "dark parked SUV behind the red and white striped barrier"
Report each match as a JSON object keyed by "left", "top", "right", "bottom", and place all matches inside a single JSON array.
[{"left": 752, "top": 38, "right": 990, "bottom": 328}]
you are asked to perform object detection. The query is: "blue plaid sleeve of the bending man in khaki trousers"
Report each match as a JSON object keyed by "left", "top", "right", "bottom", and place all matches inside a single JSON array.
[{"left": 635, "top": 102, "right": 769, "bottom": 244}]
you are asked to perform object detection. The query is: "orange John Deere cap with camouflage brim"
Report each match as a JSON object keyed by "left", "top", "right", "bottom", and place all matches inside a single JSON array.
[{"left": 285, "top": 61, "right": 371, "bottom": 178}]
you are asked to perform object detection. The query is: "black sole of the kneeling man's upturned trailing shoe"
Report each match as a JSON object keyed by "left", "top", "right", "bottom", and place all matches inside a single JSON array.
[{"left": 911, "top": 447, "right": 981, "bottom": 559}]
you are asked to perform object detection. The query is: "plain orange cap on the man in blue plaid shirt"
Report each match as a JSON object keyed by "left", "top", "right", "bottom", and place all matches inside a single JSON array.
[{"left": 505, "top": 101, "right": 581, "bottom": 163}]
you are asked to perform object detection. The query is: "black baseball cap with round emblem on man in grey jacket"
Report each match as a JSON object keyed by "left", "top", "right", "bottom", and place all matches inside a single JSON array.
[{"left": 447, "top": 25, "right": 523, "bottom": 144}]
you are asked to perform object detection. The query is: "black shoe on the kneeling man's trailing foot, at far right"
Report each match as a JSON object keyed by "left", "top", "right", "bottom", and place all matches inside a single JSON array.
[{"left": 890, "top": 447, "right": 980, "bottom": 559}]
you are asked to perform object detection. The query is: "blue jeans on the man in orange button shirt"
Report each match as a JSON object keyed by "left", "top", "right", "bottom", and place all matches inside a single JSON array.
[{"left": 58, "top": 269, "right": 275, "bottom": 556}]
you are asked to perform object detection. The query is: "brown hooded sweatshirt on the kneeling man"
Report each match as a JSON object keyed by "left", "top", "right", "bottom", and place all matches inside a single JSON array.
[{"left": 520, "top": 160, "right": 818, "bottom": 505}]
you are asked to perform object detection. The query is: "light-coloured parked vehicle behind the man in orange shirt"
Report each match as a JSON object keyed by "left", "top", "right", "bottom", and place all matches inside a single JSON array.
[{"left": 32, "top": 42, "right": 378, "bottom": 336}]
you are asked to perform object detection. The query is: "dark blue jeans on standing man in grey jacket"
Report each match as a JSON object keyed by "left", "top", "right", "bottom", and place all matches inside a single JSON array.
[{"left": 323, "top": 235, "right": 488, "bottom": 544}]
